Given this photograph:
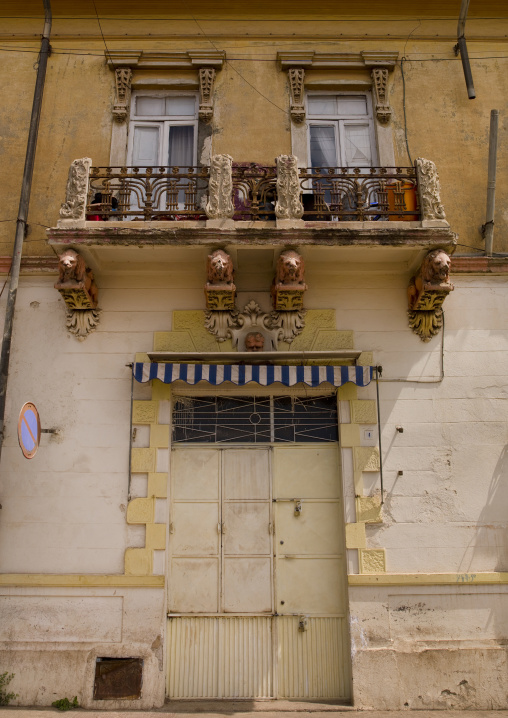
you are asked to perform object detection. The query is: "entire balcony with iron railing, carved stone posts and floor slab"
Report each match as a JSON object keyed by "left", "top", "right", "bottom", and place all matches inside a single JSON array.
[{"left": 48, "top": 155, "right": 456, "bottom": 265}]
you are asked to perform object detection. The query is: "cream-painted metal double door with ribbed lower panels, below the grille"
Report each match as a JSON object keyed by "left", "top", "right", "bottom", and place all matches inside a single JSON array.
[{"left": 167, "top": 443, "right": 350, "bottom": 700}]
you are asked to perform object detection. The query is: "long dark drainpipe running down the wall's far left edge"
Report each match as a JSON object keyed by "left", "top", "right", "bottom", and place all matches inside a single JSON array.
[{"left": 0, "top": 0, "right": 52, "bottom": 464}]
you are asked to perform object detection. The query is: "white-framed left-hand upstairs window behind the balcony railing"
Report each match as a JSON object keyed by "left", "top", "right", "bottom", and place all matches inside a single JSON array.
[{"left": 129, "top": 93, "right": 198, "bottom": 168}]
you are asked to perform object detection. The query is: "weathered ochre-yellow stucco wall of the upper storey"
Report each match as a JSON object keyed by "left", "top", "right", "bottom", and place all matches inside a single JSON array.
[{"left": 0, "top": 0, "right": 508, "bottom": 255}]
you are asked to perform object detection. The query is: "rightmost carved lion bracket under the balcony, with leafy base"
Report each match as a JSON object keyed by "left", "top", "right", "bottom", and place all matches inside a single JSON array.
[{"left": 407, "top": 249, "right": 453, "bottom": 342}]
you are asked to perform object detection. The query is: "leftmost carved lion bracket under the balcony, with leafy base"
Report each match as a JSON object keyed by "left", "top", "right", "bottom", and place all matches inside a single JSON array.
[{"left": 55, "top": 249, "right": 100, "bottom": 341}]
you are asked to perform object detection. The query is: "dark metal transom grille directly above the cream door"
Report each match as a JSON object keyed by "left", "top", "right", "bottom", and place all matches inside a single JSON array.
[{"left": 173, "top": 395, "right": 338, "bottom": 444}]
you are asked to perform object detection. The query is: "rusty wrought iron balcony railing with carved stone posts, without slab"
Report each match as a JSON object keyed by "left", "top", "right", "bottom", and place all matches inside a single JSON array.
[{"left": 60, "top": 155, "right": 445, "bottom": 222}]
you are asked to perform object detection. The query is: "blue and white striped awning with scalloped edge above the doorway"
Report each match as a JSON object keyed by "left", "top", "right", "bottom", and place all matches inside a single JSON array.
[{"left": 133, "top": 362, "right": 374, "bottom": 386}]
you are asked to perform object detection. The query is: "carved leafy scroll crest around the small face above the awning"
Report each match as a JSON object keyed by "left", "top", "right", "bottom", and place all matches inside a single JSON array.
[{"left": 205, "top": 300, "right": 305, "bottom": 351}]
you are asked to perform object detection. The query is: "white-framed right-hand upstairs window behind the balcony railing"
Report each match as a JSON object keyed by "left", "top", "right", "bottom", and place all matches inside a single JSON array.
[{"left": 307, "top": 94, "right": 377, "bottom": 167}]
